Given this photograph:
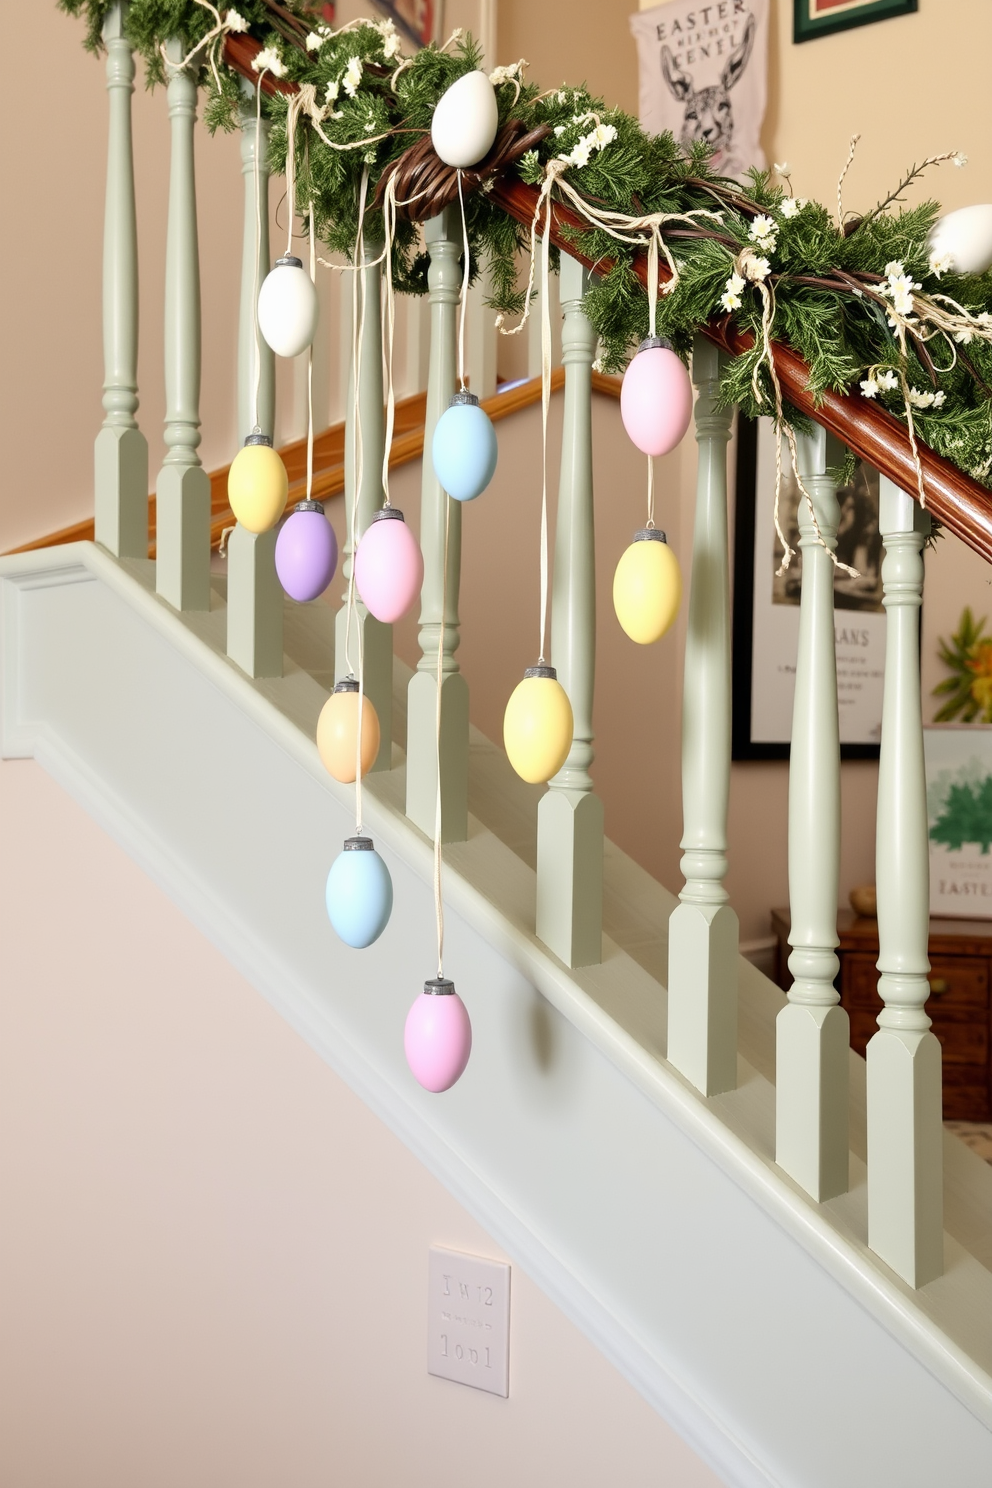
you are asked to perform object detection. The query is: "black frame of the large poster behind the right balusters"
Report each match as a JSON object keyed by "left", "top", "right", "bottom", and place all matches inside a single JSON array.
[{"left": 730, "top": 415, "right": 879, "bottom": 760}]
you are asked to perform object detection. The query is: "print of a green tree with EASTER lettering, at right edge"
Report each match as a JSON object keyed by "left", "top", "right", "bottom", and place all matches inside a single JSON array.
[{"left": 924, "top": 723, "right": 992, "bottom": 920}]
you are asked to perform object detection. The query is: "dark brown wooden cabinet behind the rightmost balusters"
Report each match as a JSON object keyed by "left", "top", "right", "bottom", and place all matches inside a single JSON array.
[{"left": 772, "top": 909, "right": 992, "bottom": 1122}]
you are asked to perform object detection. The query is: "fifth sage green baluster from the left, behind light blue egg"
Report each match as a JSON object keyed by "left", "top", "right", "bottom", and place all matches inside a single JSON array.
[{"left": 406, "top": 208, "right": 468, "bottom": 842}]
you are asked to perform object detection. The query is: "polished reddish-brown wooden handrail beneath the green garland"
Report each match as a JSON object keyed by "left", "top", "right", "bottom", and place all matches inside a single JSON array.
[{"left": 225, "top": 36, "right": 992, "bottom": 562}]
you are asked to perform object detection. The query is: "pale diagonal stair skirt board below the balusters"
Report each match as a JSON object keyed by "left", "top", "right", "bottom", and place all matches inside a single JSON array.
[{"left": 0, "top": 543, "right": 992, "bottom": 1488}]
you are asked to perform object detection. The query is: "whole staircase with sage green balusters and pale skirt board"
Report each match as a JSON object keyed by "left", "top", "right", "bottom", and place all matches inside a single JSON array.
[{"left": 0, "top": 4, "right": 992, "bottom": 1488}]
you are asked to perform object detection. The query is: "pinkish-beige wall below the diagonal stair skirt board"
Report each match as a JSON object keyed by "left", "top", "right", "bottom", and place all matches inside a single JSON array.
[{"left": 0, "top": 760, "right": 717, "bottom": 1488}]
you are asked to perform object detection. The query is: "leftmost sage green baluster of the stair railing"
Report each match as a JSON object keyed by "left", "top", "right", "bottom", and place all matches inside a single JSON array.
[{"left": 94, "top": 3, "right": 149, "bottom": 558}]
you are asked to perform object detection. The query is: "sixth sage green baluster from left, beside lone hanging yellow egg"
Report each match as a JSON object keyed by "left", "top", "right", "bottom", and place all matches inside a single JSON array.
[{"left": 537, "top": 253, "right": 602, "bottom": 966}]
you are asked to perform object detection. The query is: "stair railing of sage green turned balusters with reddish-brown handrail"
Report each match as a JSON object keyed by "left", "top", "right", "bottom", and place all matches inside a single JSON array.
[{"left": 87, "top": 34, "right": 975, "bottom": 1286}]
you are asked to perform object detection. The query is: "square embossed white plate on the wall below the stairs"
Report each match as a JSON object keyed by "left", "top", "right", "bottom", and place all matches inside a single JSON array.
[{"left": 427, "top": 1245, "right": 510, "bottom": 1397}]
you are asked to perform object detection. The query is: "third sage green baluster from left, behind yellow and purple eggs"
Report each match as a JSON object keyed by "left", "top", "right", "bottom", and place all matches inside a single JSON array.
[{"left": 228, "top": 80, "right": 283, "bottom": 677}]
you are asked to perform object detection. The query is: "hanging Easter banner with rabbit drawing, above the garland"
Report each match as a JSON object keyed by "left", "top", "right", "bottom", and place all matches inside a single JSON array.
[{"left": 631, "top": 0, "right": 769, "bottom": 176}]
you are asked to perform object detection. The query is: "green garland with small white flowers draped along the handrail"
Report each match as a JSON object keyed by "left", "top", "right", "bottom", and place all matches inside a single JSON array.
[{"left": 59, "top": 0, "right": 992, "bottom": 485}]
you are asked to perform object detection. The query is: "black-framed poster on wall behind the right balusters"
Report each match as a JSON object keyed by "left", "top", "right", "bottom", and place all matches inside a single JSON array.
[{"left": 733, "top": 418, "right": 885, "bottom": 759}]
